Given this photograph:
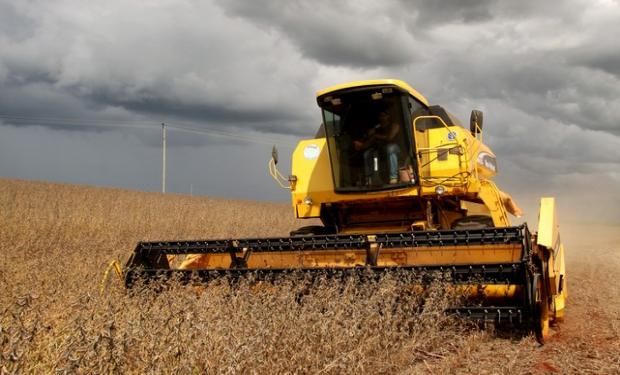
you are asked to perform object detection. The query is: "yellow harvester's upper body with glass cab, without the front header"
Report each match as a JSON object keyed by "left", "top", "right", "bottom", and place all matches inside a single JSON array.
[{"left": 289, "top": 80, "right": 521, "bottom": 233}]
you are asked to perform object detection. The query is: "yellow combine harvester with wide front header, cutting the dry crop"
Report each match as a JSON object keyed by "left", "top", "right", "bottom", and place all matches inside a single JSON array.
[{"left": 125, "top": 79, "right": 567, "bottom": 341}]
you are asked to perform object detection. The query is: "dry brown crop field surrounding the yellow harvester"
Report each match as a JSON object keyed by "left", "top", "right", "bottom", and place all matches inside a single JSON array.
[{"left": 0, "top": 179, "right": 620, "bottom": 374}]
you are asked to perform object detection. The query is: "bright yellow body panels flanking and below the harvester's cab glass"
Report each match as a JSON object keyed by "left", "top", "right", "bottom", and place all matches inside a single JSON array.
[{"left": 291, "top": 108, "right": 509, "bottom": 226}]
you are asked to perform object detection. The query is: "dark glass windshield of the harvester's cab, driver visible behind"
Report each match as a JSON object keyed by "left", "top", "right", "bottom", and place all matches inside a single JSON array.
[{"left": 319, "top": 87, "right": 415, "bottom": 192}]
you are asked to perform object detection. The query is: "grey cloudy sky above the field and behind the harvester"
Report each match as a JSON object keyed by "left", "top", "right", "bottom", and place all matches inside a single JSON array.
[{"left": 0, "top": 0, "right": 620, "bottom": 223}]
